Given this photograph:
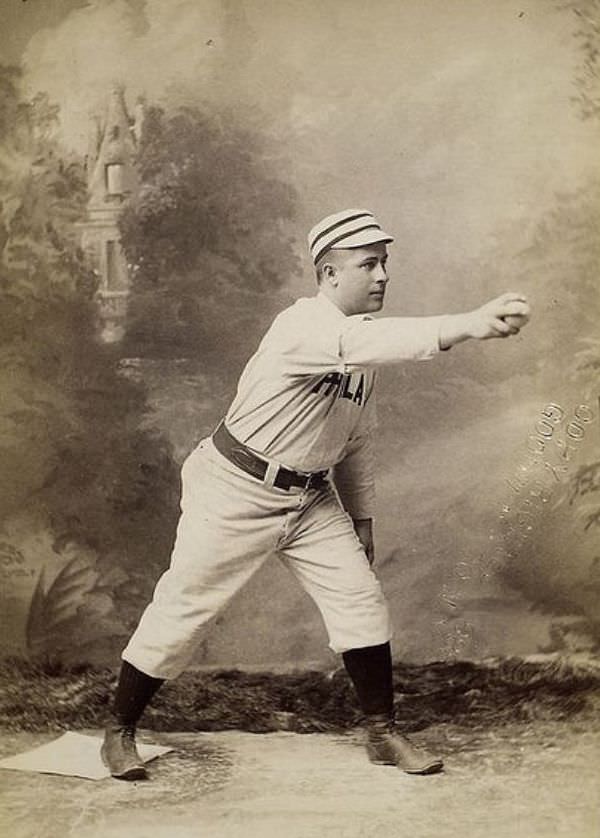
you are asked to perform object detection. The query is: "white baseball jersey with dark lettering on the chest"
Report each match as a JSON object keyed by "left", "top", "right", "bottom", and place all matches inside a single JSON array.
[{"left": 225, "top": 292, "right": 443, "bottom": 518}]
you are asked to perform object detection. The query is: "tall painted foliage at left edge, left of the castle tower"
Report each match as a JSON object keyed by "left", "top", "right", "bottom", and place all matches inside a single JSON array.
[{"left": 0, "top": 68, "right": 177, "bottom": 659}]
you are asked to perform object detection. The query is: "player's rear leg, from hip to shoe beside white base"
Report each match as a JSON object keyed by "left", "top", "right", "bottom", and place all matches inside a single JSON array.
[{"left": 102, "top": 442, "right": 293, "bottom": 780}]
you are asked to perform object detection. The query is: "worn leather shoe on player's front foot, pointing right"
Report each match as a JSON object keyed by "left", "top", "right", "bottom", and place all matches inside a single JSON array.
[{"left": 367, "top": 716, "right": 444, "bottom": 774}]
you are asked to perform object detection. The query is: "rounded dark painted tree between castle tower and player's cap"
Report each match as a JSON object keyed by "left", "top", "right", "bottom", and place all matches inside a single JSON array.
[{"left": 121, "top": 101, "right": 299, "bottom": 368}]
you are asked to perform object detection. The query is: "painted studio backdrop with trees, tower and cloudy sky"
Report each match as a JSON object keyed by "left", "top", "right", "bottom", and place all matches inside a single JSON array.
[{"left": 0, "top": 0, "right": 600, "bottom": 666}]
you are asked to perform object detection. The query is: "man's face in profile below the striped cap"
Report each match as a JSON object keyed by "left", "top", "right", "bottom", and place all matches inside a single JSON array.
[{"left": 325, "top": 242, "right": 388, "bottom": 315}]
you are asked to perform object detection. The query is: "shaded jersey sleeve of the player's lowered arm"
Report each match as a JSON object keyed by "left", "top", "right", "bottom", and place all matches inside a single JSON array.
[{"left": 333, "top": 390, "right": 376, "bottom": 519}]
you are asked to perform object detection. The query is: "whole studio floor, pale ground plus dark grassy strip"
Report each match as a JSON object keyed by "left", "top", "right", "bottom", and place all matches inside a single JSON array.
[{"left": 0, "top": 658, "right": 600, "bottom": 838}]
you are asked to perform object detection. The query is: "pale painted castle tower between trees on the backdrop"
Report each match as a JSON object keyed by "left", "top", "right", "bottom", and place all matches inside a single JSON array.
[{"left": 80, "top": 86, "right": 143, "bottom": 342}]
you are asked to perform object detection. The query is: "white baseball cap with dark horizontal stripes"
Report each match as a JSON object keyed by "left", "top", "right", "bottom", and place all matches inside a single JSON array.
[{"left": 308, "top": 209, "right": 394, "bottom": 265}]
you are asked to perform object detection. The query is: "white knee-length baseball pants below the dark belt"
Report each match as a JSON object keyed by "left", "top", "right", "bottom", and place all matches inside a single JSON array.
[{"left": 122, "top": 438, "right": 391, "bottom": 678}]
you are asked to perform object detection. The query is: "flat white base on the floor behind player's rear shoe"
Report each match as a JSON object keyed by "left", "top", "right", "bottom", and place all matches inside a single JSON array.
[{"left": 0, "top": 731, "right": 173, "bottom": 780}]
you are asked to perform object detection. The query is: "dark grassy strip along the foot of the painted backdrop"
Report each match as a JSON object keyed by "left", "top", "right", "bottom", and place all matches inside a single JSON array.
[{"left": 0, "top": 656, "right": 600, "bottom": 733}]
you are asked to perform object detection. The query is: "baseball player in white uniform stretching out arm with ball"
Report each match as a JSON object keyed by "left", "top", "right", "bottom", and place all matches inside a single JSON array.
[{"left": 102, "top": 209, "right": 529, "bottom": 780}]
